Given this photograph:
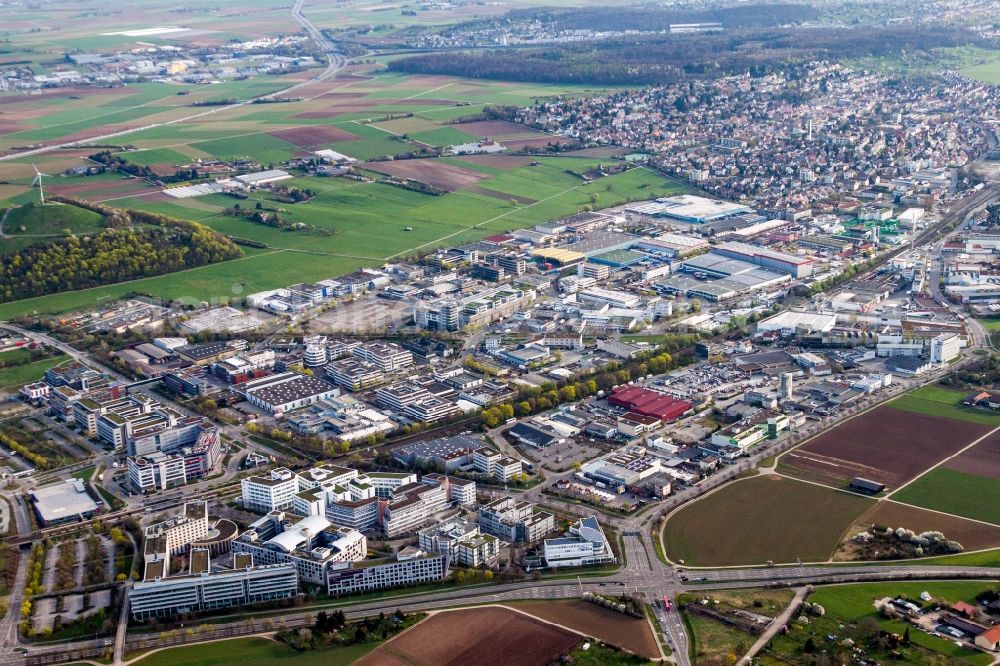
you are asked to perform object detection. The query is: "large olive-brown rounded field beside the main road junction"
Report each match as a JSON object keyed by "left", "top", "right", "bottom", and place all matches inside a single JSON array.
[{"left": 664, "top": 476, "right": 872, "bottom": 566}]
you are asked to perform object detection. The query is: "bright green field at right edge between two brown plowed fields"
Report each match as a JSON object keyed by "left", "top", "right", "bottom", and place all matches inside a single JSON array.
[{"left": 893, "top": 467, "right": 1000, "bottom": 525}]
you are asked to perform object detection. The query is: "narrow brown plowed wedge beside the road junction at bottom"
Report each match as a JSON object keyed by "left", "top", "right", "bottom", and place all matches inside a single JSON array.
[{"left": 510, "top": 593, "right": 660, "bottom": 659}]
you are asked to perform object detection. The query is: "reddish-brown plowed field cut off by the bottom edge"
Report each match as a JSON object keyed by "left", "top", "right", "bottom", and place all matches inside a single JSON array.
[{"left": 355, "top": 607, "right": 580, "bottom": 666}]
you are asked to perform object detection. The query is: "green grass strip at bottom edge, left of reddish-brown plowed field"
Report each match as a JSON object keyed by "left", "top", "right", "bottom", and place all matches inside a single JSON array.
[{"left": 135, "top": 638, "right": 379, "bottom": 666}]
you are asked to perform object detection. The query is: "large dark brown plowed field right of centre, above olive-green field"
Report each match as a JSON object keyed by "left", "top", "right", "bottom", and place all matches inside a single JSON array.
[{"left": 781, "top": 407, "right": 990, "bottom": 489}]
